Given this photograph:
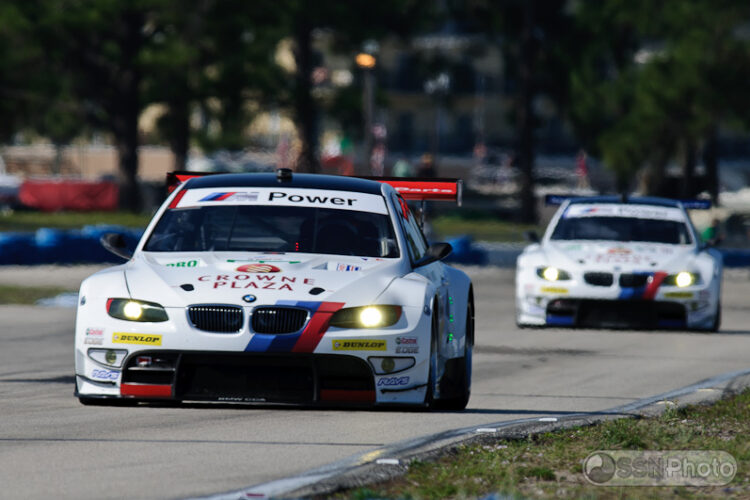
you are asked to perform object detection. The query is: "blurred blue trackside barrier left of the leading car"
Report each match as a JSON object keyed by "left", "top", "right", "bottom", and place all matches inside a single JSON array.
[{"left": 0, "top": 225, "right": 143, "bottom": 265}]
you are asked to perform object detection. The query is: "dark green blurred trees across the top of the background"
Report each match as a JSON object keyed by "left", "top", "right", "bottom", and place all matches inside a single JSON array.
[{"left": 0, "top": 0, "right": 750, "bottom": 221}]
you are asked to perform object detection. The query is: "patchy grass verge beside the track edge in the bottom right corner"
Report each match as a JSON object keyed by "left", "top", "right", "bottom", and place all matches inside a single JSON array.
[{"left": 330, "top": 390, "right": 750, "bottom": 499}]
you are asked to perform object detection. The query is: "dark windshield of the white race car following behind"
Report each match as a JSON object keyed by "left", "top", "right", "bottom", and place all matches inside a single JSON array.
[{"left": 550, "top": 217, "right": 692, "bottom": 245}]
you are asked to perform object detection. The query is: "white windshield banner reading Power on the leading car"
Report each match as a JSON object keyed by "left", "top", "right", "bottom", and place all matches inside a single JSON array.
[{"left": 173, "top": 187, "right": 388, "bottom": 215}]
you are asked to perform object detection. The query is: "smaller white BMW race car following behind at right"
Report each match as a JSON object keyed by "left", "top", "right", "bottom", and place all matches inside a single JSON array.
[{"left": 516, "top": 196, "right": 722, "bottom": 331}]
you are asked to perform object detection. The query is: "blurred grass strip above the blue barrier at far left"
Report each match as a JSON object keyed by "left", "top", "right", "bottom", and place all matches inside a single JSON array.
[{"left": 0, "top": 211, "right": 151, "bottom": 231}]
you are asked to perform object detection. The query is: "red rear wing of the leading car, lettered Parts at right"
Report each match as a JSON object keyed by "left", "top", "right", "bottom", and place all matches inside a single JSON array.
[{"left": 167, "top": 171, "right": 463, "bottom": 207}]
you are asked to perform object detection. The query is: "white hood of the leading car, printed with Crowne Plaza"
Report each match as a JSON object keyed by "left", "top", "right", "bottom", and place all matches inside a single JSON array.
[{"left": 125, "top": 252, "right": 399, "bottom": 307}]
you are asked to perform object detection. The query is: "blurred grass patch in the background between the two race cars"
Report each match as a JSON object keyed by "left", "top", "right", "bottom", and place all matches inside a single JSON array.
[{"left": 431, "top": 212, "right": 543, "bottom": 242}]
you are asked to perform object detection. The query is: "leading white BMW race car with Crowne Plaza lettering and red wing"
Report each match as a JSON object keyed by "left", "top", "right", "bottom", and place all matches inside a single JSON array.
[{"left": 75, "top": 169, "right": 474, "bottom": 409}]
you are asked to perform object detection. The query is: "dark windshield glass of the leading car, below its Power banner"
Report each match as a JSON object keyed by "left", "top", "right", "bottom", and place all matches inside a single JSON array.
[{"left": 144, "top": 205, "right": 399, "bottom": 257}]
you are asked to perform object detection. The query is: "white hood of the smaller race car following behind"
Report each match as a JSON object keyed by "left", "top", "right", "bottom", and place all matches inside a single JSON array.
[{"left": 544, "top": 241, "right": 696, "bottom": 272}]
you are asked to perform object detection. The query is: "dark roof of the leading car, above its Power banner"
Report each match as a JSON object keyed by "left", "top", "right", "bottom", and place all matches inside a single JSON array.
[{"left": 185, "top": 173, "right": 383, "bottom": 195}]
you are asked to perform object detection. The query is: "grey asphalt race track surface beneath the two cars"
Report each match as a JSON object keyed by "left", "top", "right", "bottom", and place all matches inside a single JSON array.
[{"left": 0, "top": 268, "right": 750, "bottom": 499}]
